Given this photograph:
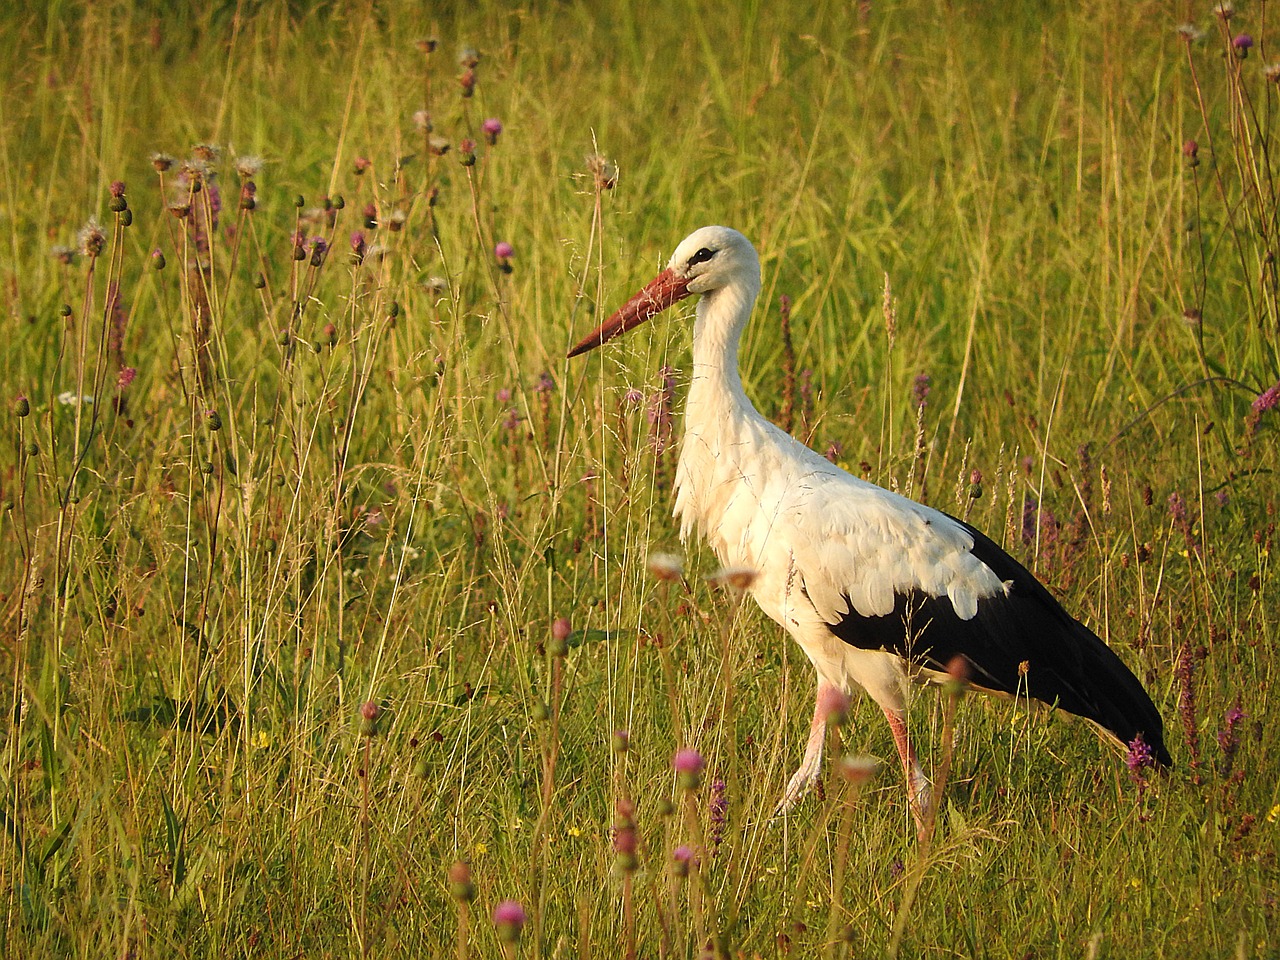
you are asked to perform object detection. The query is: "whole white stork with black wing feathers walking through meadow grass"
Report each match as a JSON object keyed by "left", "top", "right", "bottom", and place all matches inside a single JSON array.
[{"left": 568, "top": 227, "right": 1171, "bottom": 828}]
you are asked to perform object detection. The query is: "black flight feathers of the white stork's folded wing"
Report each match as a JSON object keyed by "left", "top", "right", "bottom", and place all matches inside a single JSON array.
[{"left": 831, "top": 517, "right": 1172, "bottom": 765}]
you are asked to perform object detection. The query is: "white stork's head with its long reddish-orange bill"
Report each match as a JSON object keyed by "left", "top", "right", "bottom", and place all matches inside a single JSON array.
[{"left": 568, "top": 227, "right": 760, "bottom": 357}]
